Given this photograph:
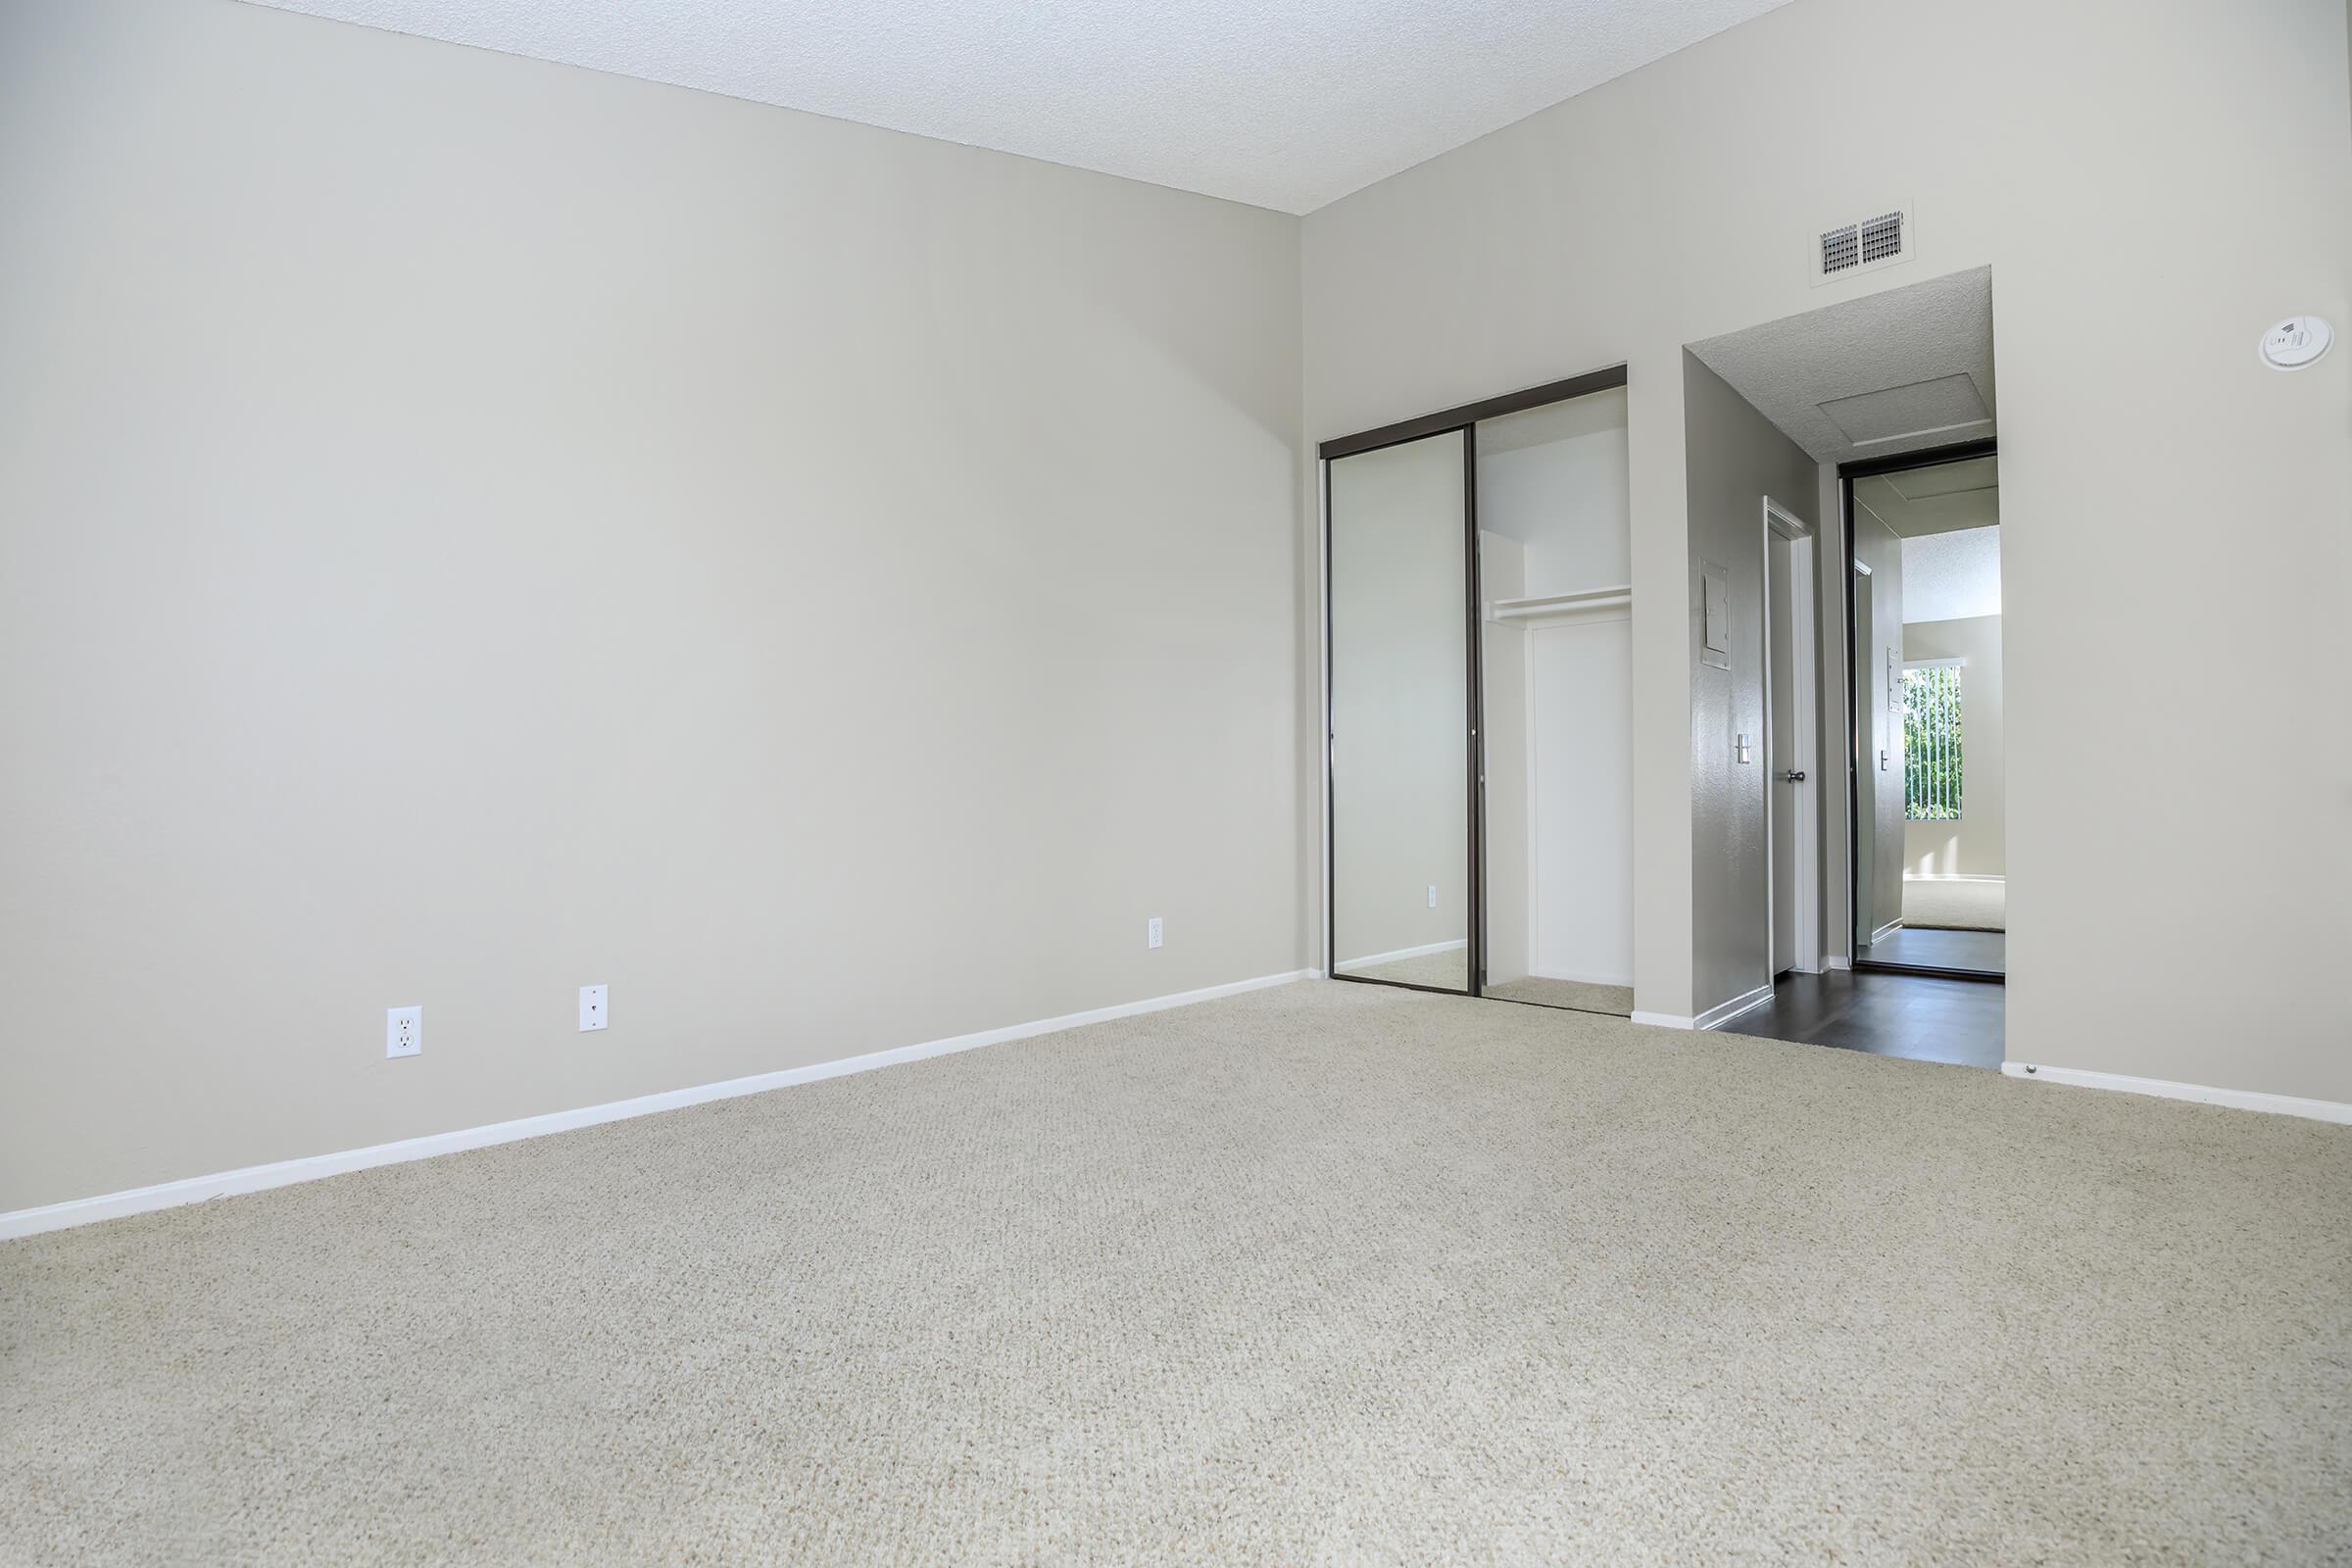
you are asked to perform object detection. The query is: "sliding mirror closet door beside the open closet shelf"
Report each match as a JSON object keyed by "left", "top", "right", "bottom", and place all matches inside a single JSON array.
[{"left": 1327, "top": 430, "right": 1472, "bottom": 992}]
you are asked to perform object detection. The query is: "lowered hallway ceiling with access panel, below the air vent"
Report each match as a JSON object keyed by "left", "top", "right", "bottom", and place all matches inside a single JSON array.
[{"left": 1691, "top": 268, "right": 1999, "bottom": 464}]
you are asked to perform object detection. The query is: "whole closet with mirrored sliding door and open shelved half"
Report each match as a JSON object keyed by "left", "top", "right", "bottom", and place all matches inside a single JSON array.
[{"left": 1322, "top": 369, "right": 1633, "bottom": 1013}]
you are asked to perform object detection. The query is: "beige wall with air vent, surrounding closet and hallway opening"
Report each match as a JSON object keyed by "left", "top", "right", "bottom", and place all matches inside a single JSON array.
[{"left": 1305, "top": 0, "right": 2352, "bottom": 1101}]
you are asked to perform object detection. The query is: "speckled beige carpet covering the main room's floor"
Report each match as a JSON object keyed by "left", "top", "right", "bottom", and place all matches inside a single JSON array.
[{"left": 0, "top": 983, "right": 2352, "bottom": 1566}]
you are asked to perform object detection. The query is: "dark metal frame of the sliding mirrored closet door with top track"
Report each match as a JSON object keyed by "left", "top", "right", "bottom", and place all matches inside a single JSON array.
[{"left": 1315, "top": 365, "right": 1637, "bottom": 997}]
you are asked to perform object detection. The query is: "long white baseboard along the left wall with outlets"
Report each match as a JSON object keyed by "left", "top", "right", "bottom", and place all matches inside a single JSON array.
[{"left": 0, "top": 968, "right": 1326, "bottom": 1242}]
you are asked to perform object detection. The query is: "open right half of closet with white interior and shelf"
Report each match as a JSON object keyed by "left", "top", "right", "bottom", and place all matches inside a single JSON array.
[{"left": 1475, "top": 388, "right": 1633, "bottom": 1013}]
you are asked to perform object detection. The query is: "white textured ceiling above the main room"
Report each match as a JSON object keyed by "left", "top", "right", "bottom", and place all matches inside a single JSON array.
[{"left": 259, "top": 0, "right": 1786, "bottom": 212}]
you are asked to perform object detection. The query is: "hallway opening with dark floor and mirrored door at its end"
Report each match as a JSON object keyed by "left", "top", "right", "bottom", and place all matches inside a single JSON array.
[{"left": 1684, "top": 268, "right": 2009, "bottom": 1067}]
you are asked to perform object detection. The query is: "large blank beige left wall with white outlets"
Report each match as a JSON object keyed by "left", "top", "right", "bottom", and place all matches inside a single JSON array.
[{"left": 0, "top": 0, "right": 1315, "bottom": 1210}]
